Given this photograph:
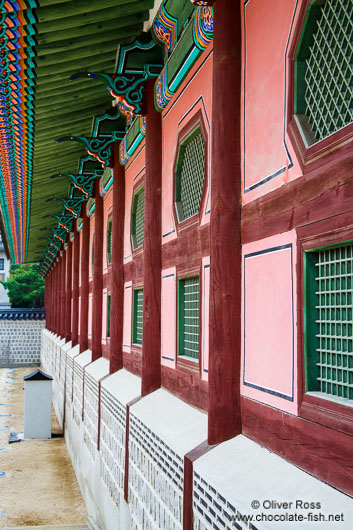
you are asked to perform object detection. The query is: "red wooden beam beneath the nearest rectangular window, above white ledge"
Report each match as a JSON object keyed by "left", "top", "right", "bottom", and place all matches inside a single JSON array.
[{"left": 241, "top": 397, "right": 353, "bottom": 495}]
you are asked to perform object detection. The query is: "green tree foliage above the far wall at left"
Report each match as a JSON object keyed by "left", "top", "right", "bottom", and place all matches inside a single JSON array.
[{"left": 1, "top": 264, "right": 44, "bottom": 308}]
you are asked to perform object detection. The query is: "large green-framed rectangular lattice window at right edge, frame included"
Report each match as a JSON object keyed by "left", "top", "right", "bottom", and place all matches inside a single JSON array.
[{"left": 304, "top": 243, "right": 353, "bottom": 403}]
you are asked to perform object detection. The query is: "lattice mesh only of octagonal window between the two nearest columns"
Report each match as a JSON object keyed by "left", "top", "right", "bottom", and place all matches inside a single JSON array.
[{"left": 180, "top": 132, "right": 205, "bottom": 219}]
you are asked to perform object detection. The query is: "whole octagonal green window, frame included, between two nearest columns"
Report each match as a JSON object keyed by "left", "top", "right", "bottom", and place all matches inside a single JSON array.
[{"left": 175, "top": 127, "right": 205, "bottom": 222}]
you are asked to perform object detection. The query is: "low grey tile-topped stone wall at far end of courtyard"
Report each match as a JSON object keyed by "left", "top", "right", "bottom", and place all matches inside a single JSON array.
[{"left": 0, "top": 309, "right": 45, "bottom": 367}]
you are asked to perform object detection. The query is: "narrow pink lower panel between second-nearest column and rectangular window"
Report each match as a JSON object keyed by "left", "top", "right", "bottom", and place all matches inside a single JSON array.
[{"left": 161, "top": 267, "right": 176, "bottom": 368}]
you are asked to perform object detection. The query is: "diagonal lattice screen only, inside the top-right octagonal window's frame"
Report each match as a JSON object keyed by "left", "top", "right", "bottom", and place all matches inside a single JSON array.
[{"left": 305, "top": 0, "right": 353, "bottom": 140}]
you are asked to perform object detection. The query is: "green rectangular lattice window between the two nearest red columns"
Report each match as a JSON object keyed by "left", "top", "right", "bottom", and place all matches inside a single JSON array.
[{"left": 178, "top": 276, "right": 200, "bottom": 359}]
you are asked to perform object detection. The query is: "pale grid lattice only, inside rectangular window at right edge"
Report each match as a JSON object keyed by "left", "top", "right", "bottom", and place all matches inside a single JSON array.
[{"left": 316, "top": 241, "right": 353, "bottom": 399}]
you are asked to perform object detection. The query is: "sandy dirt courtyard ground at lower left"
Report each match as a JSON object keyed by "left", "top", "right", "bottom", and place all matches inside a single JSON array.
[{"left": 0, "top": 367, "right": 87, "bottom": 528}]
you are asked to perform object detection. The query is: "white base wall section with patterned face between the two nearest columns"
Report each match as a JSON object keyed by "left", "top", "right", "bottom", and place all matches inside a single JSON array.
[{"left": 129, "top": 389, "right": 207, "bottom": 530}]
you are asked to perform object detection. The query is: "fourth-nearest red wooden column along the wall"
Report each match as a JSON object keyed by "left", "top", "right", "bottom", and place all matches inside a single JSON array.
[{"left": 92, "top": 179, "right": 103, "bottom": 361}]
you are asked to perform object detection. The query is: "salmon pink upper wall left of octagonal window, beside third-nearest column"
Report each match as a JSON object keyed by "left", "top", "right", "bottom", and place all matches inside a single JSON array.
[{"left": 124, "top": 142, "right": 145, "bottom": 263}]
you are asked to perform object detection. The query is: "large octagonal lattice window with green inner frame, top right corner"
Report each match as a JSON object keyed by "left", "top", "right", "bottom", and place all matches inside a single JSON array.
[{"left": 295, "top": 0, "right": 353, "bottom": 145}]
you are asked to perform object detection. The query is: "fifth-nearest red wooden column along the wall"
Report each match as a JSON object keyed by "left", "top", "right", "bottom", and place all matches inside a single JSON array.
[{"left": 79, "top": 208, "right": 89, "bottom": 353}]
